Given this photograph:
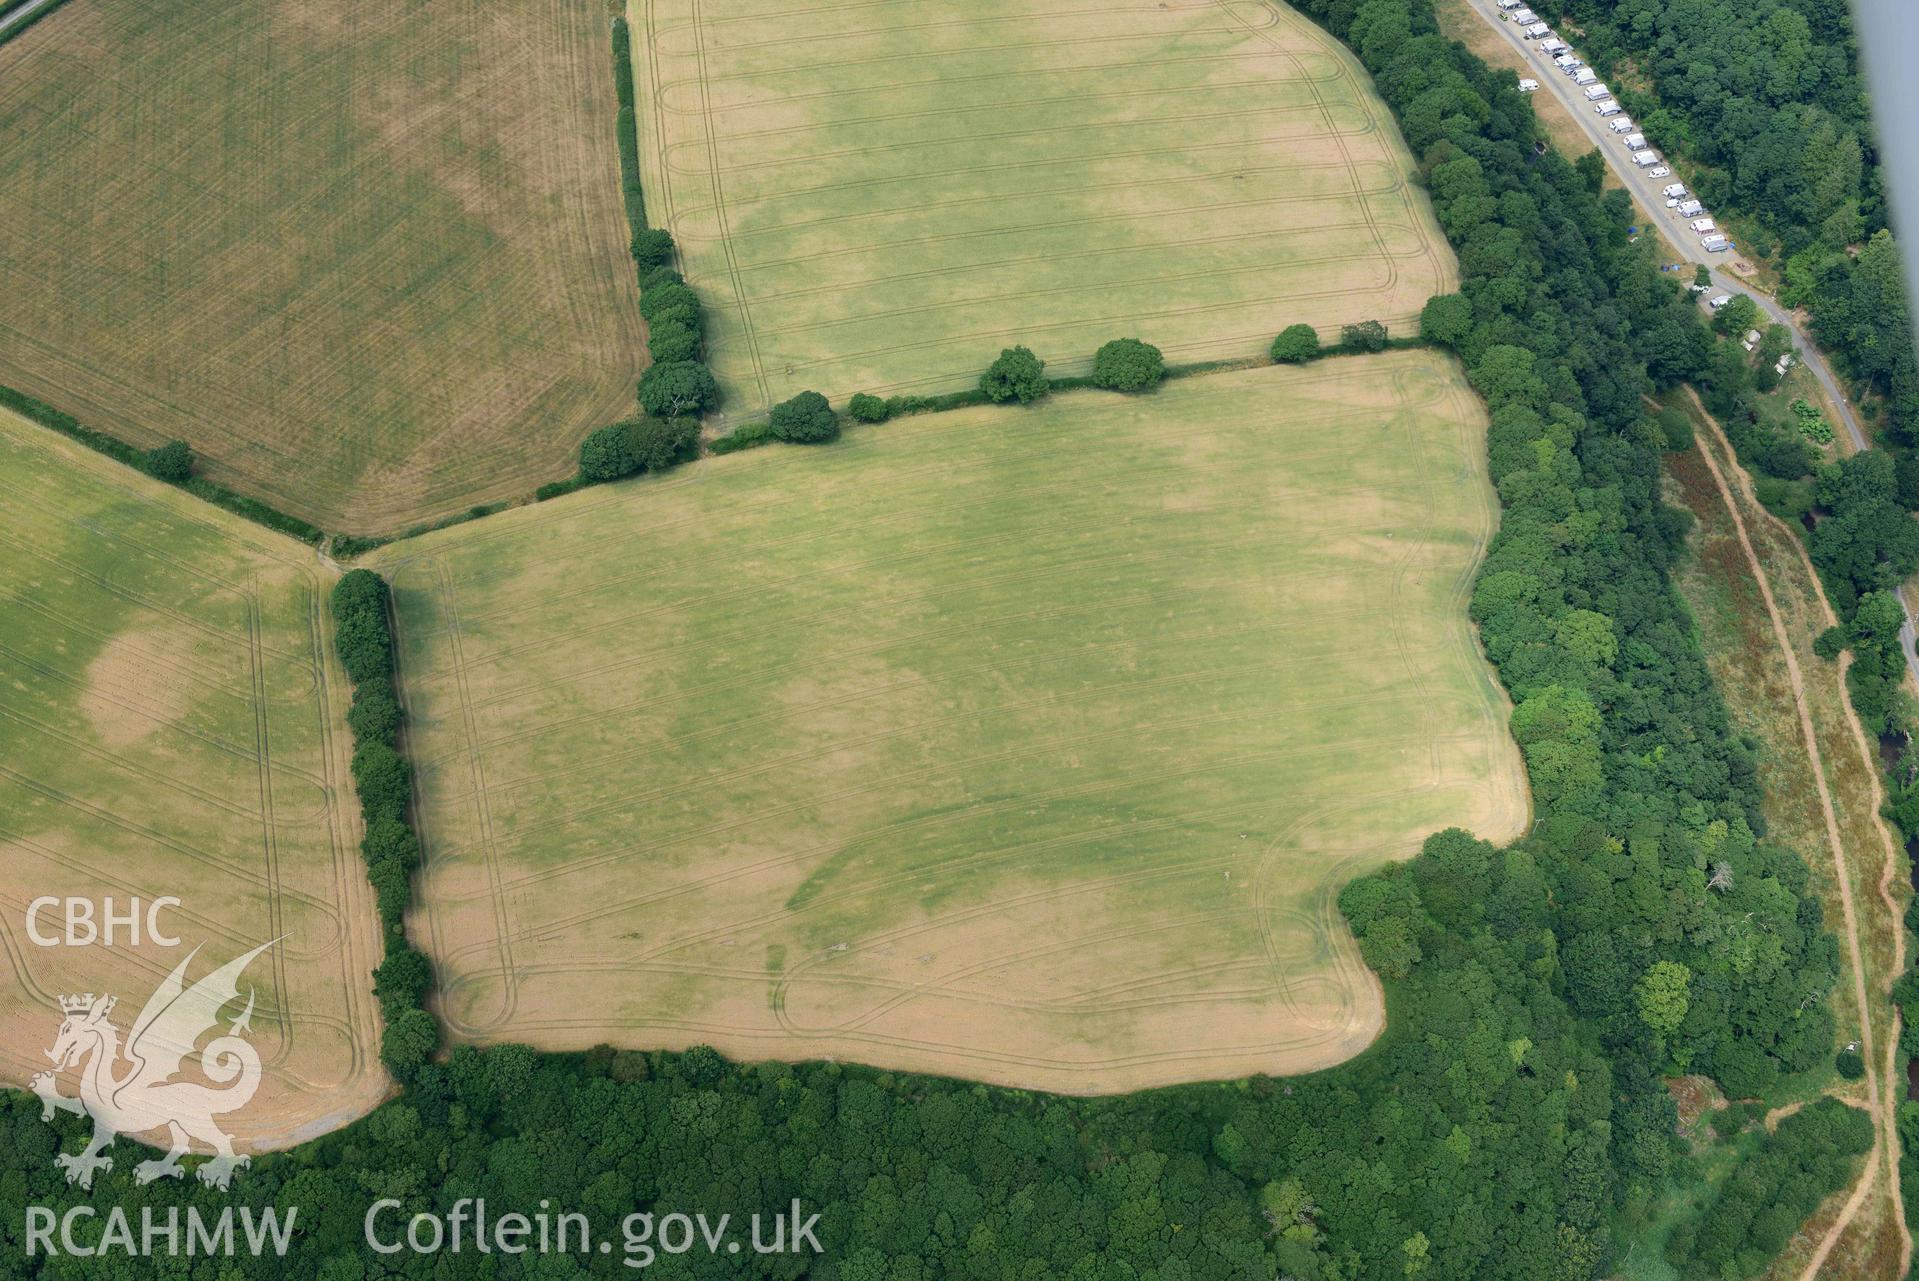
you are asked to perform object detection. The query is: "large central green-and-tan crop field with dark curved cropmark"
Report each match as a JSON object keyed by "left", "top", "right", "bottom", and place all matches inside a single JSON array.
[{"left": 374, "top": 353, "right": 1528, "bottom": 1093}]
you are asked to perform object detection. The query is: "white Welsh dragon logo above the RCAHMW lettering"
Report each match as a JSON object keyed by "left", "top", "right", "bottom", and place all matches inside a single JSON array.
[{"left": 33, "top": 940, "right": 278, "bottom": 1189}]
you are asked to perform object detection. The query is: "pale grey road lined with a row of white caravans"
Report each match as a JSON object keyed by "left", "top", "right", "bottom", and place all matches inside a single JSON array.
[{"left": 1466, "top": 0, "right": 1919, "bottom": 685}]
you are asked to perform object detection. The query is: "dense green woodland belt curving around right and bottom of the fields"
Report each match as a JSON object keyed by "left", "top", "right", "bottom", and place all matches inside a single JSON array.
[{"left": 0, "top": 0, "right": 1836, "bottom": 1281}]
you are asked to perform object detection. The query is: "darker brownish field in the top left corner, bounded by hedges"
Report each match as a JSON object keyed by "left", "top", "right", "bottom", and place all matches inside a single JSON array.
[{"left": 0, "top": 0, "right": 643, "bottom": 533}]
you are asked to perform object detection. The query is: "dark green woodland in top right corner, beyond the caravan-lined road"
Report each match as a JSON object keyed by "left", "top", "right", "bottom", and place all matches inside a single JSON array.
[{"left": 1560, "top": 0, "right": 1919, "bottom": 449}]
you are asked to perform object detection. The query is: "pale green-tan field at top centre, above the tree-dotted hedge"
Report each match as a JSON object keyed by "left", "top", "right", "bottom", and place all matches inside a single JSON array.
[{"left": 628, "top": 0, "right": 1457, "bottom": 418}]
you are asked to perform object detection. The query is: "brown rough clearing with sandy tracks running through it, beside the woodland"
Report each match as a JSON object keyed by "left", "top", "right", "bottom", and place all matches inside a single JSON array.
[{"left": 1670, "top": 401, "right": 1904, "bottom": 1277}]
